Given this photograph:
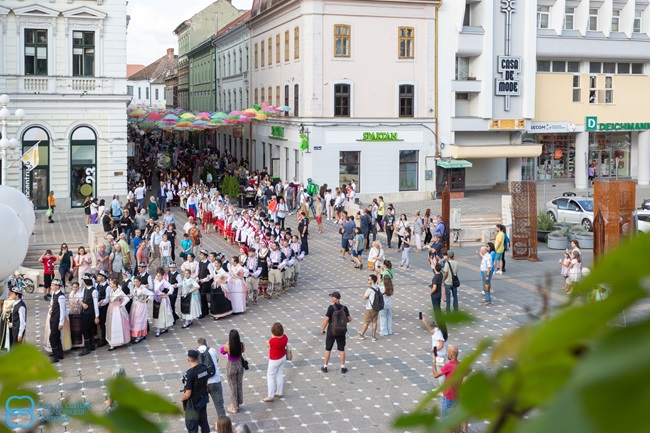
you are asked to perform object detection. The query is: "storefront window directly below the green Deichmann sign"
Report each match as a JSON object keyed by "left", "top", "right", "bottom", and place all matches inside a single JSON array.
[{"left": 589, "top": 132, "right": 630, "bottom": 178}]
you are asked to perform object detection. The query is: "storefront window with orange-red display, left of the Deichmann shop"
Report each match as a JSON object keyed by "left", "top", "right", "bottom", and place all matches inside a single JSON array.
[{"left": 537, "top": 134, "right": 576, "bottom": 180}]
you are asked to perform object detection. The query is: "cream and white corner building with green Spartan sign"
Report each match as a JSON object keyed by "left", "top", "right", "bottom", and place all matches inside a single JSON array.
[{"left": 249, "top": 0, "right": 437, "bottom": 200}]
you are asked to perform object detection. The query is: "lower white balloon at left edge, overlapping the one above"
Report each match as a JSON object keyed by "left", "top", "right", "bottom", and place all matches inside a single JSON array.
[{"left": 0, "top": 203, "right": 29, "bottom": 281}]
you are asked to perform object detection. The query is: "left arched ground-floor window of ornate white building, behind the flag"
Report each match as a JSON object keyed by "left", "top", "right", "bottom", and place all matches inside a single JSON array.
[{"left": 23, "top": 127, "right": 50, "bottom": 209}]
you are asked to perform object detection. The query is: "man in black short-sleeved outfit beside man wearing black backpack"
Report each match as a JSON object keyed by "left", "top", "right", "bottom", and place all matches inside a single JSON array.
[{"left": 181, "top": 350, "right": 210, "bottom": 433}]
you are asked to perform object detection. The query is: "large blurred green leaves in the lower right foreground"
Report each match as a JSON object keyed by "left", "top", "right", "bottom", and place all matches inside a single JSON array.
[{"left": 395, "top": 235, "right": 650, "bottom": 433}]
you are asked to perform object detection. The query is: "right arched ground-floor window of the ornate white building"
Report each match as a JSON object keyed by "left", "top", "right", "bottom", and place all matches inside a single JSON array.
[{"left": 70, "top": 126, "right": 97, "bottom": 207}]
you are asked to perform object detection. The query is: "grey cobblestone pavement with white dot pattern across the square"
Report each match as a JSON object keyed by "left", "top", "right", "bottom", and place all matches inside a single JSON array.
[{"left": 16, "top": 186, "right": 645, "bottom": 433}]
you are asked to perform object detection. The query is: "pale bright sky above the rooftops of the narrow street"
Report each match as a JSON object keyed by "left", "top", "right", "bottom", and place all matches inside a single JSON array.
[{"left": 126, "top": 0, "right": 253, "bottom": 66}]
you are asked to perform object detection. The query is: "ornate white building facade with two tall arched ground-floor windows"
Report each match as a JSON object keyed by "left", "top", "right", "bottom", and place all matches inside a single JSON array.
[{"left": 0, "top": 0, "right": 130, "bottom": 208}]
